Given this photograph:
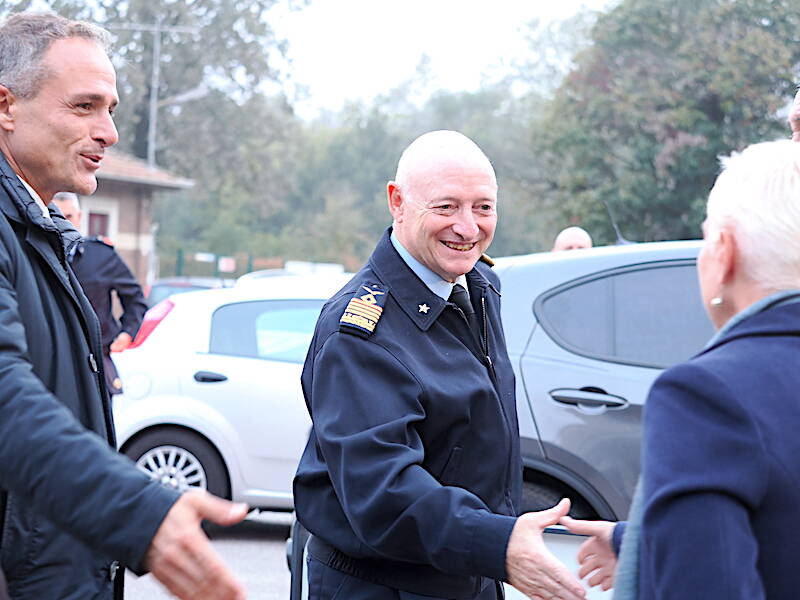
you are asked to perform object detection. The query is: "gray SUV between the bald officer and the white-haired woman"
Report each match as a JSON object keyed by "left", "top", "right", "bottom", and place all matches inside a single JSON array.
[{"left": 495, "top": 241, "right": 713, "bottom": 520}]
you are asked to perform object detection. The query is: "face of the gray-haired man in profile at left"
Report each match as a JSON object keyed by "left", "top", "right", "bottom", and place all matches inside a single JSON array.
[{"left": 0, "top": 37, "right": 118, "bottom": 202}]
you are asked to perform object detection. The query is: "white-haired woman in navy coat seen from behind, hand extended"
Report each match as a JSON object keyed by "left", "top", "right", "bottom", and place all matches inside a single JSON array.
[{"left": 563, "top": 140, "right": 800, "bottom": 600}]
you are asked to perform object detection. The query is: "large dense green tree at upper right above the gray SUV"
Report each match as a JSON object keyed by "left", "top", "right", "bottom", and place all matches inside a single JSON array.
[{"left": 531, "top": 0, "right": 800, "bottom": 242}]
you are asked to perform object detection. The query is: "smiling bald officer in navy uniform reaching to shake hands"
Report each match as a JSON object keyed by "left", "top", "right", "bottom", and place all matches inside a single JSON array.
[{"left": 294, "top": 131, "right": 584, "bottom": 600}]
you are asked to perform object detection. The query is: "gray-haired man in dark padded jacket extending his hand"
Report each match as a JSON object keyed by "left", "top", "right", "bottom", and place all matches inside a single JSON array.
[{"left": 0, "top": 13, "right": 246, "bottom": 600}]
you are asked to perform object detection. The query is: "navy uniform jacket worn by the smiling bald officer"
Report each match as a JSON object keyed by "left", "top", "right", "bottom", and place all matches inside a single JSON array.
[{"left": 294, "top": 230, "right": 522, "bottom": 598}]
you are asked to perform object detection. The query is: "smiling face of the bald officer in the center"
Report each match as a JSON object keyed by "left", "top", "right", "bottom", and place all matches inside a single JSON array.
[{"left": 388, "top": 155, "right": 497, "bottom": 281}]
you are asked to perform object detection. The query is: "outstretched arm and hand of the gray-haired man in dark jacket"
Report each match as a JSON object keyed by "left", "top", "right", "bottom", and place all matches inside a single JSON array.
[{"left": 0, "top": 269, "right": 246, "bottom": 600}]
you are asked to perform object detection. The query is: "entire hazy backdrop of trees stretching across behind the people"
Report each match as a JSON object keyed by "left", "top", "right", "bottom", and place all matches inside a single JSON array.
[{"left": 0, "top": 0, "right": 800, "bottom": 269}]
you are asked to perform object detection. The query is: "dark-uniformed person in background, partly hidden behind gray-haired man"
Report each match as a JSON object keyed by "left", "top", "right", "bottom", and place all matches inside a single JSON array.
[{"left": 53, "top": 192, "right": 147, "bottom": 394}]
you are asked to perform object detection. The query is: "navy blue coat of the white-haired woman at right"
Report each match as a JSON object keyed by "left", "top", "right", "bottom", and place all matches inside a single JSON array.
[{"left": 639, "top": 304, "right": 800, "bottom": 600}]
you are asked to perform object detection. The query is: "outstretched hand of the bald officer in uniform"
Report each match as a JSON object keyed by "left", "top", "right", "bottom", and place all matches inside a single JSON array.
[{"left": 506, "top": 498, "right": 586, "bottom": 600}]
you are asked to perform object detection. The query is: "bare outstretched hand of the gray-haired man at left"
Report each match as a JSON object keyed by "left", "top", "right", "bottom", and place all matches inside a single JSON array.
[{"left": 145, "top": 491, "right": 248, "bottom": 600}]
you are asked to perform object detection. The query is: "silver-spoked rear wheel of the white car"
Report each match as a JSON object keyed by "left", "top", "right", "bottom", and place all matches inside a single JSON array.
[{"left": 125, "top": 428, "right": 230, "bottom": 498}]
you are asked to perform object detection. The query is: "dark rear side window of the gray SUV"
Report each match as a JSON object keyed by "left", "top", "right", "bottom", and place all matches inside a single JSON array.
[{"left": 536, "top": 263, "right": 713, "bottom": 368}]
